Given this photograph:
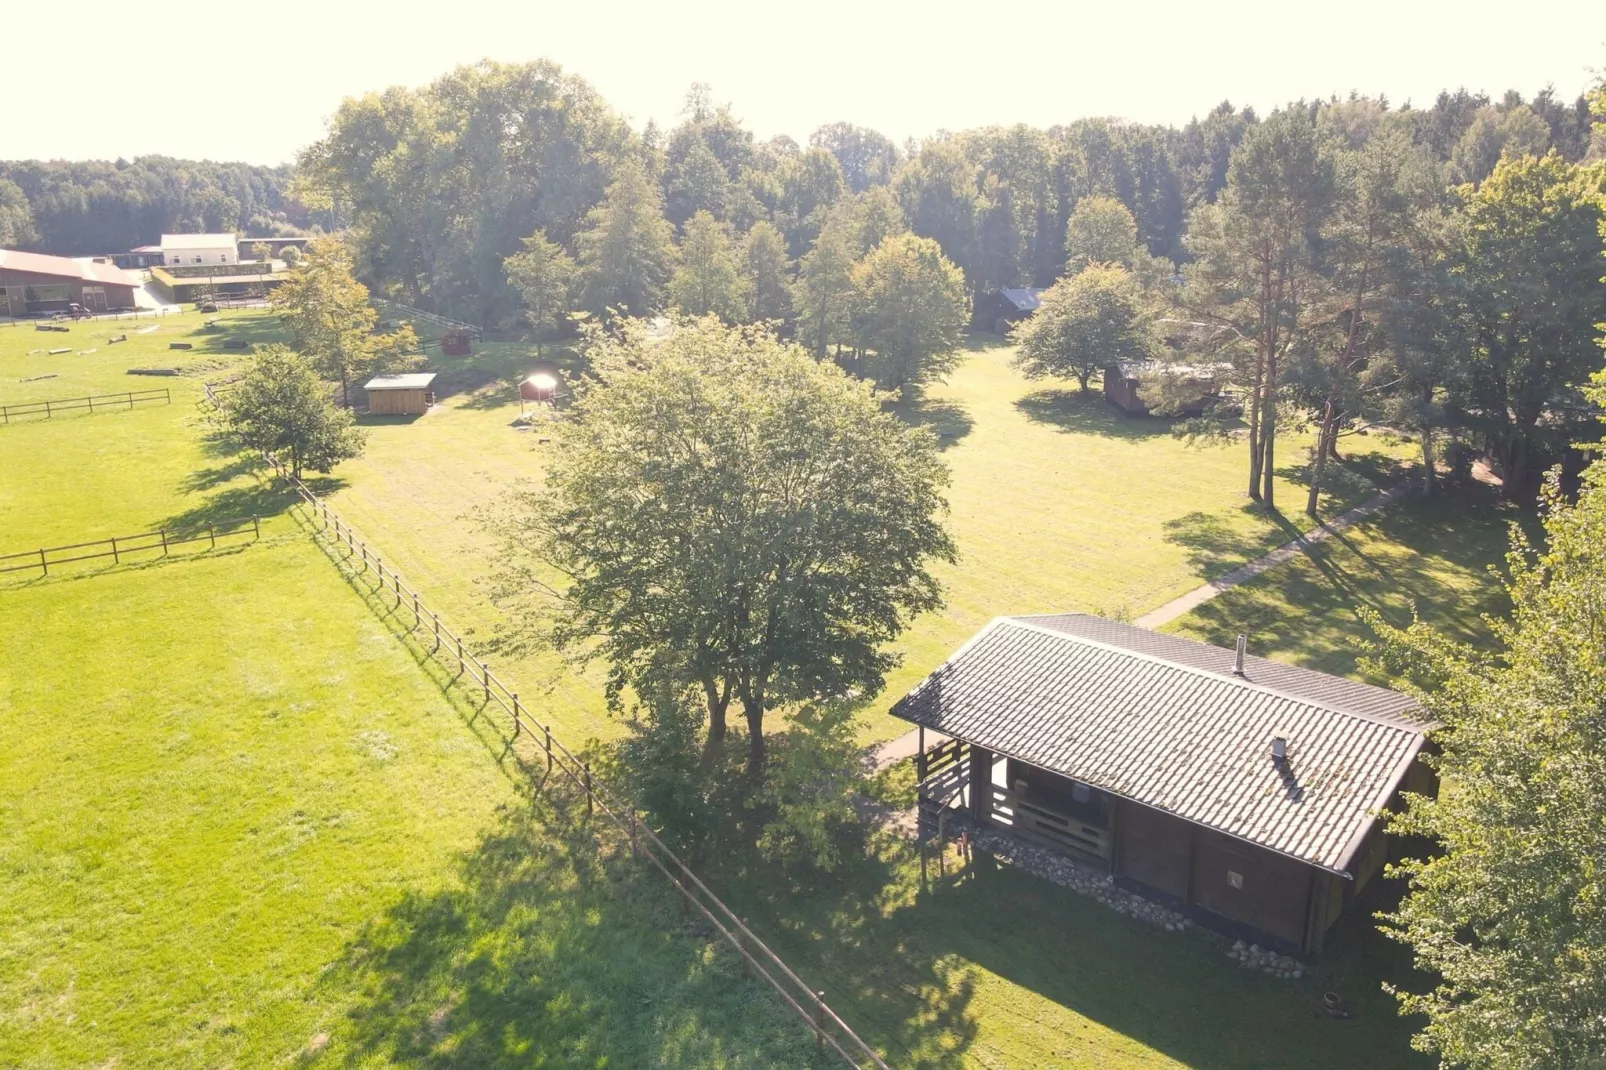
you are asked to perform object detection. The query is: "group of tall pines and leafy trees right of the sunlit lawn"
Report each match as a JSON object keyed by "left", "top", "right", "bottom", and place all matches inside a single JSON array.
[{"left": 1018, "top": 88, "right": 1606, "bottom": 514}]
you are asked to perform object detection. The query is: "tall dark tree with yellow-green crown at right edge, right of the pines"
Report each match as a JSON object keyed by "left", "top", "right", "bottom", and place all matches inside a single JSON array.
[{"left": 1461, "top": 153, "right": 1606, "bottom": 496}]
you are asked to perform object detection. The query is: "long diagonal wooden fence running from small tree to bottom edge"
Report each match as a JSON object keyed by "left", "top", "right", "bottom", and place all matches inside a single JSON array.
[{"left": 244, "top": 446, "right": 890, "bottom": 1070}]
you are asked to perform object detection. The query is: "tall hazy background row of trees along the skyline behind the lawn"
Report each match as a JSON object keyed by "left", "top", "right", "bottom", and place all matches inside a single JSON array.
[{"left": 299, "top": 63, "right": 1590, "bottom": 325}]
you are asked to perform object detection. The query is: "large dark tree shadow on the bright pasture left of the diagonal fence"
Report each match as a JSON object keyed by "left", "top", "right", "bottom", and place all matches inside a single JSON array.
[{"left": 304, "top": 805, "right": 840, "bottom": 1068}]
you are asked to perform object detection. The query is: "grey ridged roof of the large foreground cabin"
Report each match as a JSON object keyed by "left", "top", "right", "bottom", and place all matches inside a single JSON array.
[{"left": 891, "top": 615, "right": 1425, "bottom": 872}]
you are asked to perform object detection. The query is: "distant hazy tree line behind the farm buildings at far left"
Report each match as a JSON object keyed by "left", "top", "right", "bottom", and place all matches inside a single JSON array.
[{"left": 0, "top": 156, "right": 332, "bottom": 255}]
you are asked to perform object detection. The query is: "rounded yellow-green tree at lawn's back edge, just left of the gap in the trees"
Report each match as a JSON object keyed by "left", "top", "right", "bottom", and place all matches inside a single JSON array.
[{"left": 853, "top": 235, "right": 970, "bottom": 389}]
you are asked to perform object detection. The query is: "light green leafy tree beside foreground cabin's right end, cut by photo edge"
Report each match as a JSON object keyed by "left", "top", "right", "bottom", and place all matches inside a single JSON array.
[{"left": 1372, "top": 446, "right": 1606, "bottom": 1070}]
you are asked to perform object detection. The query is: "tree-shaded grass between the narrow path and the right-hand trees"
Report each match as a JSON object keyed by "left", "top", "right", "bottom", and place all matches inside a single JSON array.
[{"left": 1161, "top": 484, "right": 1537, "bottom": 683}]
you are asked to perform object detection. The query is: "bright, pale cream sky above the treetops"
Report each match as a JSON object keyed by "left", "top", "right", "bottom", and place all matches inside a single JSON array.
[{"left": 12, "top": 0, "right": 1606, "bottom": 164}]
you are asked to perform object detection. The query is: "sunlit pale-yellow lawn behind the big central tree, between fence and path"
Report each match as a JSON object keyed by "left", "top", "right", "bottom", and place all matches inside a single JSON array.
[{"left": 332, "top": 336, "right": 1408, "bottom": 739}]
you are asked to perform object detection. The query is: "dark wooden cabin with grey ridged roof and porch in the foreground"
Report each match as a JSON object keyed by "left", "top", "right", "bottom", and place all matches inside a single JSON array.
[{"left": 893, "top": 614, "right": 1434, "bottom": 954}]
